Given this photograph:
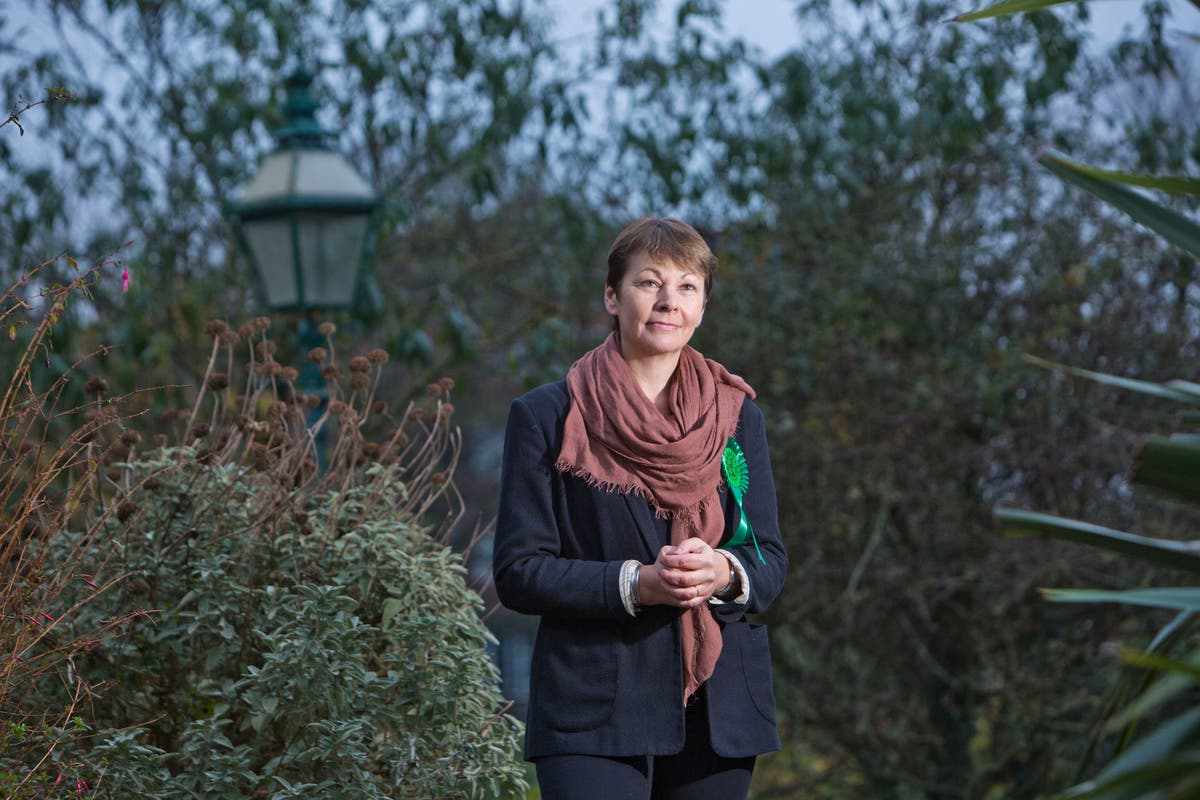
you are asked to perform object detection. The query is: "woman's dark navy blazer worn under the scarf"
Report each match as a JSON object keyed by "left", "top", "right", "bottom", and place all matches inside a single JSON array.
[{"left": 493, "top": 381, "right": 787, "bottom": 759}]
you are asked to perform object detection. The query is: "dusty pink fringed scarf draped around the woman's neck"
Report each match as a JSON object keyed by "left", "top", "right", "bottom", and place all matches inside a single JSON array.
[{"left": 556, "top": 332, "right": 755, "bottom": 703}]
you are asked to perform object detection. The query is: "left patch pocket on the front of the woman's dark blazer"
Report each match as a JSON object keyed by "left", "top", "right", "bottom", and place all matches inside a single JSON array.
[{"left": 532, "top": 619, "right": 620, "bottom": 732}]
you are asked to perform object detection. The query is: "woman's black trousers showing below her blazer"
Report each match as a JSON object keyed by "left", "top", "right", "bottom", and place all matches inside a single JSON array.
[{"left": 534, "top": 686, "right": 755, "bottom": 800}]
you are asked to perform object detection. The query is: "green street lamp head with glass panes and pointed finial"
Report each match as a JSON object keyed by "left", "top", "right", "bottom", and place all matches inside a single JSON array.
[{"left": 233, "top": 68, "right": 379, "bottom": 311}]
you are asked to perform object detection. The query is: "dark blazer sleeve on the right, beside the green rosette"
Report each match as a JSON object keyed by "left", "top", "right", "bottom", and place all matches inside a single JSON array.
[{"left": 712, "top": 399, "right": 787, "bottom": 622}]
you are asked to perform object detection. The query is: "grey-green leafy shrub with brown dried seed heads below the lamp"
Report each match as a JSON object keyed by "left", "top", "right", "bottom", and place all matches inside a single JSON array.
[{"left": 0, "top": 320, "right": 524, "bottom": 799}]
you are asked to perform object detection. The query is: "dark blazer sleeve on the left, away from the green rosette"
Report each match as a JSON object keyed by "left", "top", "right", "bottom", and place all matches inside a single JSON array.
[{"left": 492, "top": 397, "right": 632, "bottom": 620}]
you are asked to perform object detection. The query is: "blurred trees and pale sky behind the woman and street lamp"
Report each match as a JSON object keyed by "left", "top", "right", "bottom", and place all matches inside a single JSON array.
[{"left": 0, "top": 0, "right": 1200, "bottom": 800}]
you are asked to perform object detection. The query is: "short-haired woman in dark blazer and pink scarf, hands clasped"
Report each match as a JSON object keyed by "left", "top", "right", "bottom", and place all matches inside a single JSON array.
[{"left": 493, "top": 218, "right": 787, "bottom": 800}]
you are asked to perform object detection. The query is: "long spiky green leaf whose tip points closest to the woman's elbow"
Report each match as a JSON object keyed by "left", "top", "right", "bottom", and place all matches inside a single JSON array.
[{"left": 992, "top": 507, "right": 1200, "bottom": 572}]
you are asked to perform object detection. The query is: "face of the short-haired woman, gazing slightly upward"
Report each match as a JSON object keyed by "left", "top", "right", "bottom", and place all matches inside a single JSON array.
[{"left": 604, "top": 252, "right": 707, "bottom": 361}]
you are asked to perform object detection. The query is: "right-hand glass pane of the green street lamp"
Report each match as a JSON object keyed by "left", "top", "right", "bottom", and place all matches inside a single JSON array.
[{"left": 299, "top": 213, "right": 368, "bottom": 308}]
